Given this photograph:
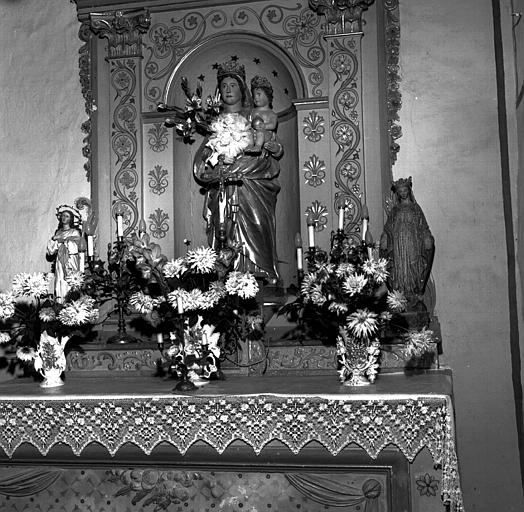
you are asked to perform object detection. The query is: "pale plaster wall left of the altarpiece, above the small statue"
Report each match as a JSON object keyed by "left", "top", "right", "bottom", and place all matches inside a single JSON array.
[{"left": 0, "top": 0, "right": 89, "bottom": 290}]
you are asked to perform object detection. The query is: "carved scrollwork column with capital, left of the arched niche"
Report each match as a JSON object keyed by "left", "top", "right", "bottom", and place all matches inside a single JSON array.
[{"left": 90, "top": 9, "right": 151, "bottom": 237}]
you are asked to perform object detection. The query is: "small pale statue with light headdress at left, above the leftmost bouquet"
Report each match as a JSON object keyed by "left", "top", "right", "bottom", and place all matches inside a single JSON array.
[{"left": 47, "top": 205, "right": 82, "bottom": 301}]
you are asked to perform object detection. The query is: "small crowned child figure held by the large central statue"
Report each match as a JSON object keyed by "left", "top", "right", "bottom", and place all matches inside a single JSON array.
[{"left": 245, "top": 75, "right": 278, "bottom": 154}]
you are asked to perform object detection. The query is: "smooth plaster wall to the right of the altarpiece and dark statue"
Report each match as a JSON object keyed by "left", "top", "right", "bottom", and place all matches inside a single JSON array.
[{"left": 393, "top": 0, "right": 524, "bottom": 512}]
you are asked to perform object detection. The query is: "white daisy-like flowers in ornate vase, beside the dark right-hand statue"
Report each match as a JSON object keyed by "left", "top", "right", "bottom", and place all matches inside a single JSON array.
[{"left": 283, "top": 243, "right": 432, "bottom": 386}]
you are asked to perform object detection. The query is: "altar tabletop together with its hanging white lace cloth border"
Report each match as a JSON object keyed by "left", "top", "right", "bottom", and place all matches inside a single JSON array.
[{"left": 0, "top": 372, "right": 463, "bottom": 512}]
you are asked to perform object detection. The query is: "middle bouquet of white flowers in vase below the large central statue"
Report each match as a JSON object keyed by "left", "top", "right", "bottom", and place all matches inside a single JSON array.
[{"left": 125, "top": 235, "right": 259, "bottom": 379}]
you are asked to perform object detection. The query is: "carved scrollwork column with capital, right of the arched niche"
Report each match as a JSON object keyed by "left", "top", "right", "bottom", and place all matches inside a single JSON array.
[{"left": 309, "top": 0, "right": 373, "bottom": 243}]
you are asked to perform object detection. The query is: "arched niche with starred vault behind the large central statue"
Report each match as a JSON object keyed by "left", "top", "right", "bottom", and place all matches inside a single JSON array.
[{"left": 164, "top": 33, "right": 306, "bottom": 286}]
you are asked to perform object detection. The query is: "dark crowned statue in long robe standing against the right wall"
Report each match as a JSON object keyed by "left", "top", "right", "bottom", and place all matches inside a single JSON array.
[{"left": 380, "top": 177, "right": 435, "bottom": 311}]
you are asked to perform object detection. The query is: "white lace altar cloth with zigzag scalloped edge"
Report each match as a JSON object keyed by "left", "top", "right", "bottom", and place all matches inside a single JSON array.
[{"left": 0, "top": 380, "right": 464, "bottom": 512}]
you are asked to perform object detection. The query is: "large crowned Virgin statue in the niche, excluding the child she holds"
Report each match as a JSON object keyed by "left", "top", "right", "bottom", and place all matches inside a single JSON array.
[{"left": 193, "top": 61, "right": 284, "bottom": 283}]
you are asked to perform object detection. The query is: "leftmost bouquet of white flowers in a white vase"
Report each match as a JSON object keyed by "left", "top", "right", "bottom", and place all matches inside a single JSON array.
[{"left": 0, "top": 272, "right": 98, "bottom": 387}]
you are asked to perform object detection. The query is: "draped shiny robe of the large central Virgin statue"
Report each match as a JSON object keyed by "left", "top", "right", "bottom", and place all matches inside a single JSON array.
[{"left": 194, "top": 112, "right": 282, "bottom": 278}]
